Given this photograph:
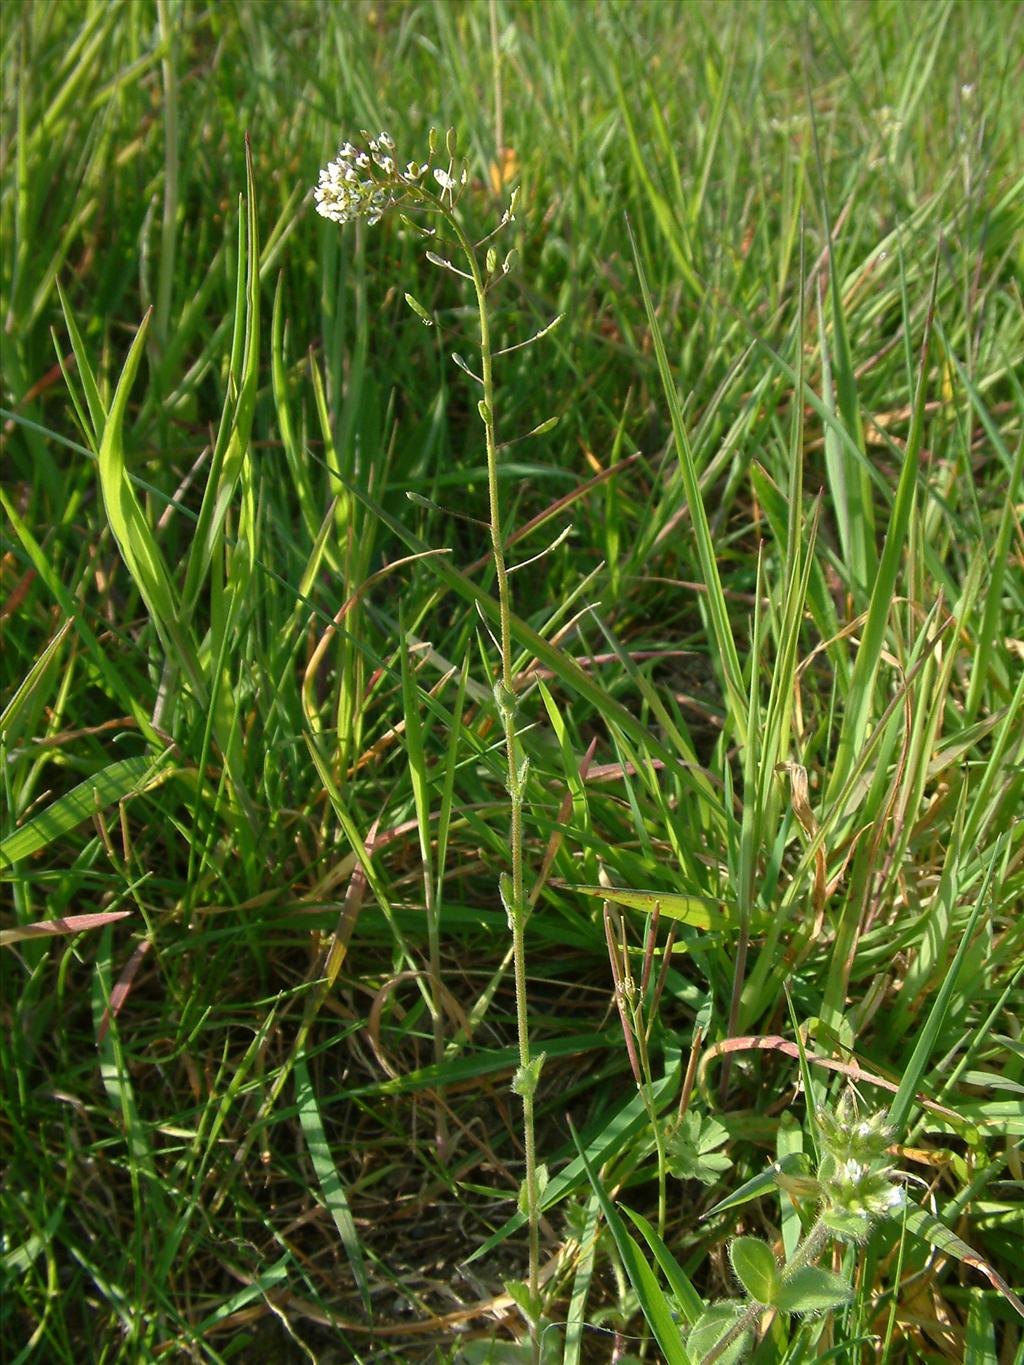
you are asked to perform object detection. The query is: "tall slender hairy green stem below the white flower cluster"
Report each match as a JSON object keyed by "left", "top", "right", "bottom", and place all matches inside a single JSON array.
[{"left": 448, "top": 214, "right": 541, "bottom": 1321}]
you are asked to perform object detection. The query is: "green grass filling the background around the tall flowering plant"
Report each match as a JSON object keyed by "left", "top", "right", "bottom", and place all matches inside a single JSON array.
[{"left": 0, "top": 0, "right": 1024, "bottom": 1361}]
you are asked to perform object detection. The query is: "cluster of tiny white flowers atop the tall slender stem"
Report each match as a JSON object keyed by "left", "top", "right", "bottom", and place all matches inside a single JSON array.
[{"left": 313, "top": 130, "right": 467, "bottom": 227}]
